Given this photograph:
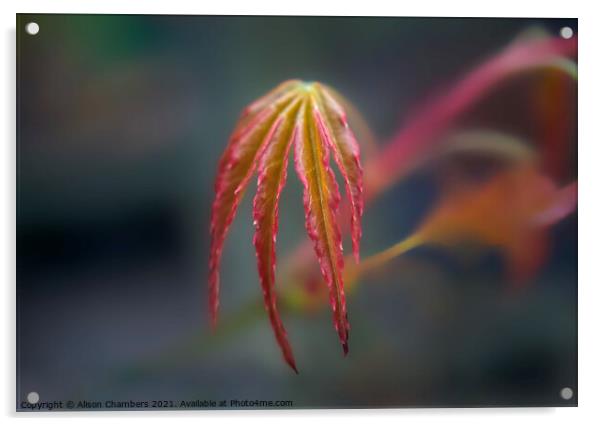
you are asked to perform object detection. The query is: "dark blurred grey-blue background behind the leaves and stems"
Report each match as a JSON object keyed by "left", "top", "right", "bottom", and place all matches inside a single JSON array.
[{"left": 17, "top": 15, "right": 577, "bottom": 408}]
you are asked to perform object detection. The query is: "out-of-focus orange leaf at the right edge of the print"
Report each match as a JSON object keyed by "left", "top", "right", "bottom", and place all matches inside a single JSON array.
[{"left": 414, "top": 167, "right": 577, "bottom": 281}]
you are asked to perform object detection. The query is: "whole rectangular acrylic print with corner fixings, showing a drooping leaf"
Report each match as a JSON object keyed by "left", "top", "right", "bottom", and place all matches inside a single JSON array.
[{"left": 16, "top": 15, "right": 578, "bottom": 411}]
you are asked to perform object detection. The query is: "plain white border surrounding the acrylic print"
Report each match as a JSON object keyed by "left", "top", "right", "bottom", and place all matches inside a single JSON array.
[{"left": 0, "top": 0, "right": 602, "bottom": 426}]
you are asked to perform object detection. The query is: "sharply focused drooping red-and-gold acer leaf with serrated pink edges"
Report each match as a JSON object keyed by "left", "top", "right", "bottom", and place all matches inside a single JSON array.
[{"left": 209, "top": 80, "right": 363, "bottom": 371}]
